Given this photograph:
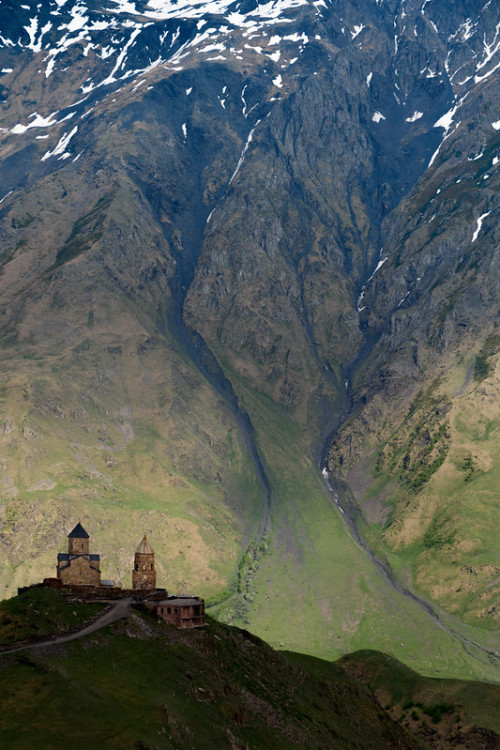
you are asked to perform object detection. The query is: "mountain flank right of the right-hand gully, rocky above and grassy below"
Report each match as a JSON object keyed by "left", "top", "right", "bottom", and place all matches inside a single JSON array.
[{"left": 329, "top": 1, "right": 500, "bottom": 629}]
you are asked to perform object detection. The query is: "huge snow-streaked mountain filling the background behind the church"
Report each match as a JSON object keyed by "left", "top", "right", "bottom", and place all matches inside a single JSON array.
[{"left": 0, "top": 0, "right": 500, "bottom": 679}]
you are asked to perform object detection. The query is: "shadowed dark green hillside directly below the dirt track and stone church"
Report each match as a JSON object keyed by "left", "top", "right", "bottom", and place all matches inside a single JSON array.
[{"left": 0, "top": 605, "right": 421, "bottom": 750}]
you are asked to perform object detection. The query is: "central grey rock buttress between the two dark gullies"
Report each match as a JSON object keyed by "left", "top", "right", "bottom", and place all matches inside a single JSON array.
[{"left": 185, "top": 63, "right": 369, "bottom": 424}]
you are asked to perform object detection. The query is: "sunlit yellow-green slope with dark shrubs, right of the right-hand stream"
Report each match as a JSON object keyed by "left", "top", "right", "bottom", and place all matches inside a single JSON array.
[{"left": 334, "top": 351, "right": 500, "bottom": 643}]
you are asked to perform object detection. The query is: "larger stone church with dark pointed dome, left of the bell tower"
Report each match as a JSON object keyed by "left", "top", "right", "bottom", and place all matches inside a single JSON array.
[{"left": 57, "top": 523, "right": 101, "bottom": 586}]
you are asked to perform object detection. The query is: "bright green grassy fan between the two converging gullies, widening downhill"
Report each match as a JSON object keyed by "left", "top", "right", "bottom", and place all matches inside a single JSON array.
[{"left": 206, "top": 378, "right": 499, "bottom": 680}]
